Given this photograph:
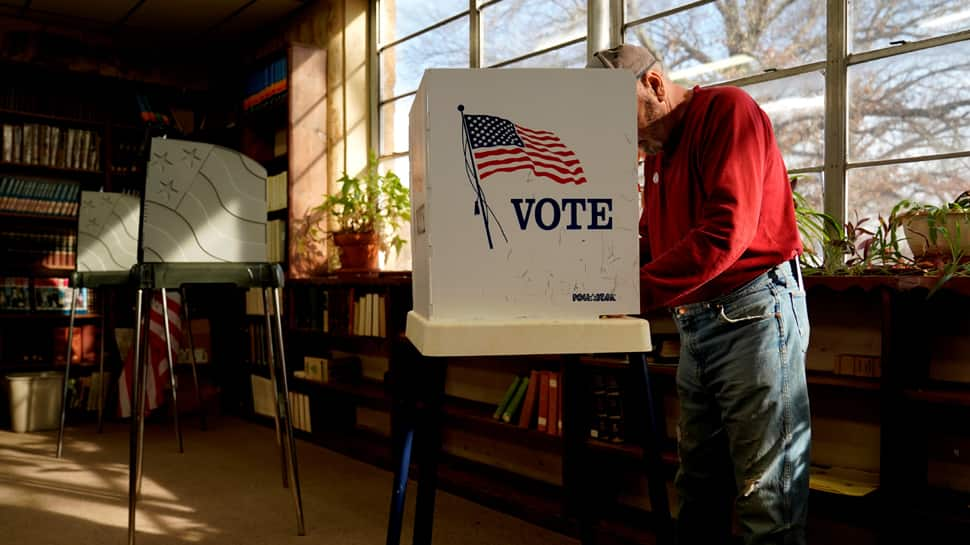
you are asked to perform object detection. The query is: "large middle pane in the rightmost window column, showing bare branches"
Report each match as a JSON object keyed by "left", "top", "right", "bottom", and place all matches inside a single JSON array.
[{"left": 849, "top": 42, "right": 970, "bottom": 161}]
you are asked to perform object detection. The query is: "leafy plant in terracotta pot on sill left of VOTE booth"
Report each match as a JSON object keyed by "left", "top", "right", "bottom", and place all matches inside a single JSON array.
[{"left": 313, "top": 153, "right": 411, "bottom": 272}]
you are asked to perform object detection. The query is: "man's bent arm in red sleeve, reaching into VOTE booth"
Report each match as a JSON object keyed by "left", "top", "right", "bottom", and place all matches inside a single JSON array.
[{"left": 640, "top": 91, "right": 769, "bottom": 308}]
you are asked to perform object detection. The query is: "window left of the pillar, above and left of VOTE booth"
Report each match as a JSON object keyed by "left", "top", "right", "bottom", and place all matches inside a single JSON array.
[{"left": 372, "top": 0, "right": 587, "bottom": 269}]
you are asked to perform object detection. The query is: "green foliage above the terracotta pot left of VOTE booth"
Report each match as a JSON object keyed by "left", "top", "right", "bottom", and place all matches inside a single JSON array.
[{"left": 309, "top": 153, "right": 411, "bottom": 255}]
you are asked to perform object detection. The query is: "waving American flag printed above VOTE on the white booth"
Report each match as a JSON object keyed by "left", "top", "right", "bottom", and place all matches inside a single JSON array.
[{"left": 465, "top": 115, "right": 586, "bottom": 184}]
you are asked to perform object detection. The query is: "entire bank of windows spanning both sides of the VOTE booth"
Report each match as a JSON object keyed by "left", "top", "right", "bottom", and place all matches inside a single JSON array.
[{"left": 376, "top": 0, "right": 970, "bottom": 268}]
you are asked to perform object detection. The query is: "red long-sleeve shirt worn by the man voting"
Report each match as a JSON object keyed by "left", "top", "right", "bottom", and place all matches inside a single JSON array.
[{"left": 640, "top": 87, "right": 802, "bottom": 310}]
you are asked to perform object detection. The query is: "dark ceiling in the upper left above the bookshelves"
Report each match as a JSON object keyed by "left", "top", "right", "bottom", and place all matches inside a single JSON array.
[{"left": 0, "top": 0, "right": 307, "bottom": 47}]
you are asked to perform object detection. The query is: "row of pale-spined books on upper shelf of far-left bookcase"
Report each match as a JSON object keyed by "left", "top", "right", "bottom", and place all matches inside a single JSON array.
[{"left": 0, "top": 123, "right": 101, "bottom": 171}]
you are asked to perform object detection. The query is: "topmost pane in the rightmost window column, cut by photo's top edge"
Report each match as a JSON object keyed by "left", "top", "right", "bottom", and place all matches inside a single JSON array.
[{"left": 849, "top": 0, "right": 970, "bottom": 51}]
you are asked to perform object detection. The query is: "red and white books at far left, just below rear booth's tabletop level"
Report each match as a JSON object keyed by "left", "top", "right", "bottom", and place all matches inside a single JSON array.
[{"left": 0, "top": 276, "right": 94, "bottom": 314}]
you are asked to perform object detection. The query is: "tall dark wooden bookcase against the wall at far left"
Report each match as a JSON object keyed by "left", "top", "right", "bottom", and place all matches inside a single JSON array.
[{"left": 0, "top": 64, "right": 208, "bottom": 420}]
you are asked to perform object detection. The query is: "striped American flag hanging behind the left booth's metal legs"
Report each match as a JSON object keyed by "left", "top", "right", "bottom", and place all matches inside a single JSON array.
[{"left": 118, "top": 290, "right": 182, "bottom": 417}]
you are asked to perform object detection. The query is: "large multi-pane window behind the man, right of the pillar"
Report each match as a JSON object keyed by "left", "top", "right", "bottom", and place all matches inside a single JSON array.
[{"left": 623, "top": 0, "right": 970, "bottom": 226}]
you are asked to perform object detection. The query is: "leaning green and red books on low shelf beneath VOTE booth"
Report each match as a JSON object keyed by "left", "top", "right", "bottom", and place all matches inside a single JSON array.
[{"left": 492, "top": 370, "right": 562, "bottom": 435}]
